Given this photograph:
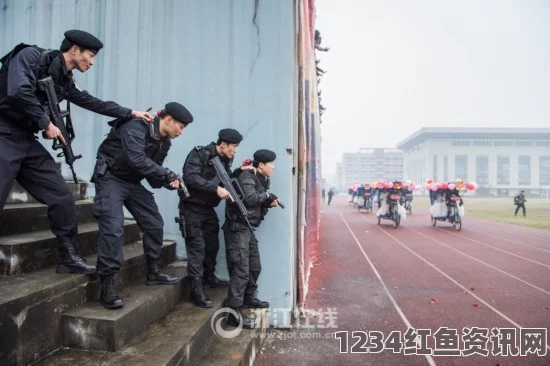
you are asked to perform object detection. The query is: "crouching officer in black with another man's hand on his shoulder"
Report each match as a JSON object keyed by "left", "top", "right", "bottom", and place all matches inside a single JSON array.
[{"left": 92, "top": 102, "right": 193, "bottom": 309}]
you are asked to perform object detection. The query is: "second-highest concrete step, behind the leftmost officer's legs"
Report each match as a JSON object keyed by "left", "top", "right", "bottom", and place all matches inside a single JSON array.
[{"left": 0, "top": 200, "right": 95, "bottom": 237}]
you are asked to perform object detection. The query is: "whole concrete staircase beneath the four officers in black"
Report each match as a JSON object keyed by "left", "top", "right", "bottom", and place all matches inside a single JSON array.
[{"left": 0, "top": 183, "right": 268, "bottom": 366}]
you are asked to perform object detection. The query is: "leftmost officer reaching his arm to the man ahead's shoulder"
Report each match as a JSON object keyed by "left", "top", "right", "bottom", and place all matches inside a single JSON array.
[{"left": 0, "top": 30, "right": 152, "bottom": 274}]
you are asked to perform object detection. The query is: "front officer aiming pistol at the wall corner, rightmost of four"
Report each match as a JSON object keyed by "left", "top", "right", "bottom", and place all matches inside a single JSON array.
[{"left": 222, "top": 149, "right": 278, "bottom": 328}]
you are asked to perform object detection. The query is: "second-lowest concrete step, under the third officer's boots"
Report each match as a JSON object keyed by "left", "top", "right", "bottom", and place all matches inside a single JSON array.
[{"left": 36, "top": 288, "right": 231, "bottom": 366}]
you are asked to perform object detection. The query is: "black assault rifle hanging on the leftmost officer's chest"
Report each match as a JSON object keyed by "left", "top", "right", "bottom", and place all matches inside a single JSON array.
[{"left": 38, "top": 76, "right": 82, "bottom": 183}]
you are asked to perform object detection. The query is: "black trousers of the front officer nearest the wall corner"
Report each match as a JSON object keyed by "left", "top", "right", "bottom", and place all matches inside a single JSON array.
[{"left": 223, "top": 219, "right": 262, "bottom": 308}]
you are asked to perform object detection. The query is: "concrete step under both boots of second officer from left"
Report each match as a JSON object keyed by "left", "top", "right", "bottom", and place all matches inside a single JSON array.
[{"left": 62, "top": 266, "right": 191, "bottom": 352}]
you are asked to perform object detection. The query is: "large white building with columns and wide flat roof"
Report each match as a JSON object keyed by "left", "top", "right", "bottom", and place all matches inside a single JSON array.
[{"left": 397, "top": 128, "right": 550, "bottom": 195}]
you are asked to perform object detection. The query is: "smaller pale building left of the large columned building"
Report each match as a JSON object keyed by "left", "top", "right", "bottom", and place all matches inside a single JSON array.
[{"left": 337, "top": 147, "right": 403, "bottom": 189}]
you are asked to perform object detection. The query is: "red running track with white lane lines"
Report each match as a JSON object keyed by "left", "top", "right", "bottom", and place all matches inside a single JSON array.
[{"left": 257, "top": 197, "right": 550, "bottom": 366}]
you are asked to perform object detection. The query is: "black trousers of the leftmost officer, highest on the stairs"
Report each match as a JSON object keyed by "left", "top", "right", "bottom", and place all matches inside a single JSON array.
[{"left": 0, "top": 126, "right": 78, "bottom": 239}]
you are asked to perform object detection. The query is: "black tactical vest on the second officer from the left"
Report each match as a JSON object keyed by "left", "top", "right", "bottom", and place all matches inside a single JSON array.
[{"left": 97, "top": 117, "right": 171, "bottom": 183}]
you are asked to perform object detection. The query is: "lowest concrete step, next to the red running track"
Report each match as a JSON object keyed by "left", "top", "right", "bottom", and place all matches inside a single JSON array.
[{"left": 198, "top": 309, "right": 269, "bottom": 366}]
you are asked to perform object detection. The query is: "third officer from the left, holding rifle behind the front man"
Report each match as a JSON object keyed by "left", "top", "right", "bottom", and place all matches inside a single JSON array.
[{"left": 179, "top": 128, "right": 250, "bottom": 308}]
